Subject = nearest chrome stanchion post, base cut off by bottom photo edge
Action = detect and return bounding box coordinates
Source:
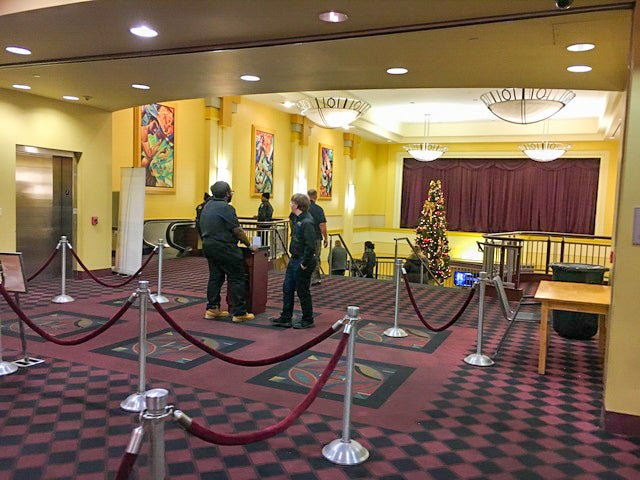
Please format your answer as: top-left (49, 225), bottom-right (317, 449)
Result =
top-left (142, 388), bottom-right (173, 480)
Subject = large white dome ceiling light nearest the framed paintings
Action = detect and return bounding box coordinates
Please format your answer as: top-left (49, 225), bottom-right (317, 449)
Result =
top-left (296, 97), bottom-right (371, 128)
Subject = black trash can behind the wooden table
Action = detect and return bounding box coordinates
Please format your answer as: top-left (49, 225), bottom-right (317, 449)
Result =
top-left (549, 263), bottom-right (609, 340)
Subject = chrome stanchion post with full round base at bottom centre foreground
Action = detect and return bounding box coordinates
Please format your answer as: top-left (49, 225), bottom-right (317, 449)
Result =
top-left (322, 306), bottom-right (369, 465)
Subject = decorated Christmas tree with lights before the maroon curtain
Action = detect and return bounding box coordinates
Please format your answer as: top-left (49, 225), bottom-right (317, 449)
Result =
top-left (416, 180), bottom-right (451, 282)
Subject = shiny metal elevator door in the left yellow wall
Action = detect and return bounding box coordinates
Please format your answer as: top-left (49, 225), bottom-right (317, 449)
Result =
top-left (16, 153), bottom-right (74, 278)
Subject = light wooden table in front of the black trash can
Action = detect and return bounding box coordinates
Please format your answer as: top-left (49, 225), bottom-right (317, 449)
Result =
top-left (534, 280), bottom-right (611, 375)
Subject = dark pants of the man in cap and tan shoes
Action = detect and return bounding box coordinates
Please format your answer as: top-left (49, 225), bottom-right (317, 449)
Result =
top-left (203, 238), bottom-right (247, 316)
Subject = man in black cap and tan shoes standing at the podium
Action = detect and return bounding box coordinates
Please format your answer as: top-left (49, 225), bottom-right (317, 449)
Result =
top-left (200, 181), bottom-right (256, 322)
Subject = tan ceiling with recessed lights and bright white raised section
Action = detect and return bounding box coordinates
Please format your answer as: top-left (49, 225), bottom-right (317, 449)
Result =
top-left (0, 0), bottom-right (635, 142)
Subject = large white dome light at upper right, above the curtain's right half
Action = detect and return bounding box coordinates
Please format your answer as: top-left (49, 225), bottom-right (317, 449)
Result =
top-left (480, 88), bottom-right (576, 124)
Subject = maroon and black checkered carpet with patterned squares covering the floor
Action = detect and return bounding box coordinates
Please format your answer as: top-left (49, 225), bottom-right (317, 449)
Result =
top-left (0, 258), bottom-right (640, 480)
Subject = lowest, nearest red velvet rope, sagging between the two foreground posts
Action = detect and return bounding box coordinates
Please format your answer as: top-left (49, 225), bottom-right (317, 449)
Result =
top-left (180, 333), bottom-right (351, 445)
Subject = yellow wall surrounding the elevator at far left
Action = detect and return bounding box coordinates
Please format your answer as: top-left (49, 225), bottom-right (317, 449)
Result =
top-left (0, 90), bottom-right (112, 269)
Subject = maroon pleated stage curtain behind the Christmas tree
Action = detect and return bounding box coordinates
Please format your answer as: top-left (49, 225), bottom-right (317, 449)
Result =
top-left (400, 158), bottom-right (600, 234)
